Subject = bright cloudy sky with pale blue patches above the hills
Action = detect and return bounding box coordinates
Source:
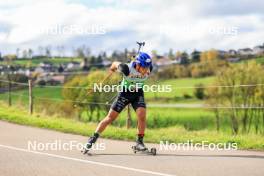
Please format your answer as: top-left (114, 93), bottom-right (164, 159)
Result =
top-left (0, 0), bottom-right (264, 54)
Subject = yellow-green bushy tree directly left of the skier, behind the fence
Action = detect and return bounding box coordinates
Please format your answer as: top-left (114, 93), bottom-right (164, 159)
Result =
top-left (63, 71), bottom-right (119, 121)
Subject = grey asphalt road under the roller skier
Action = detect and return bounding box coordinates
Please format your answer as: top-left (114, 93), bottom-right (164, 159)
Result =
top-left (0, 121), bottom-right (264, 176)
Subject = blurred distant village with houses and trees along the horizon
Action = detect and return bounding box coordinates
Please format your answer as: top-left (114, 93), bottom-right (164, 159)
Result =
top-left (0, 43), bottom-right (264, 85)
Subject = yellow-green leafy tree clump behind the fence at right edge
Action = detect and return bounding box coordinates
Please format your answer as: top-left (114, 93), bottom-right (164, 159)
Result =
top-left (206, 62), bottom-right (264, 134)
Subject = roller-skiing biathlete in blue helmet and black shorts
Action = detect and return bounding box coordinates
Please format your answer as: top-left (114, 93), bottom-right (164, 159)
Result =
top-left (84, 52), bottom-right (152, 153)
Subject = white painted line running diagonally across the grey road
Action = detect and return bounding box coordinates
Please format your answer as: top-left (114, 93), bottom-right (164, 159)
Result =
top-left (0, 144), bottom-right (176, 176)
